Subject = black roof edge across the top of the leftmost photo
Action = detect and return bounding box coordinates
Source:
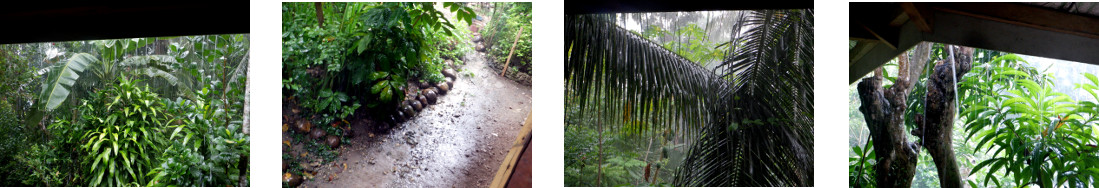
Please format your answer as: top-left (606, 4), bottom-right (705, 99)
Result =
top-left (0, 1), bottom-right (249, 44)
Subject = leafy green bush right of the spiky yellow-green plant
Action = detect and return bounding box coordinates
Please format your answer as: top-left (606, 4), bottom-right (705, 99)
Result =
top-left (143, 86), bottom-right (249, 187)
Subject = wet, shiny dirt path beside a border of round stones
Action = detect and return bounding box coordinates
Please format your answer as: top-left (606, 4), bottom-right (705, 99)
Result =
top-left (292, 13), bottom-right (531, 187)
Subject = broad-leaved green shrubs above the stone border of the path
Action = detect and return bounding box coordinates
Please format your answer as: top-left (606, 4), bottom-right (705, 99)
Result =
top-left (282, 2), bottom-right (476, 123)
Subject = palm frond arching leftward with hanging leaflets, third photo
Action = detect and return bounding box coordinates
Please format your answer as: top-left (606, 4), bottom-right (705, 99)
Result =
top-left (565, 15), bottom-right (725, 137)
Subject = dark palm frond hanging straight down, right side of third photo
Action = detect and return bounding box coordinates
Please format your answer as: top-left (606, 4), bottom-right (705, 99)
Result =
top-left (677, 10), bottom-right (813, 186)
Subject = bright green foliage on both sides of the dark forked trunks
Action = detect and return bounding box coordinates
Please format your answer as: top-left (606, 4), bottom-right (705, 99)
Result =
top-left (850, 44), bottom-right (1099, 187)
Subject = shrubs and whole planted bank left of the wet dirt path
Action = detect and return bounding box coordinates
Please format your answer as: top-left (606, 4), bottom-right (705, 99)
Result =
top-left (282, 2), bottom-right (477, 187)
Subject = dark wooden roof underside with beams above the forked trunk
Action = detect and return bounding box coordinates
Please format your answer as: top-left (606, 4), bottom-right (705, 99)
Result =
top-left (848, 2), bottom-right (1099, 82)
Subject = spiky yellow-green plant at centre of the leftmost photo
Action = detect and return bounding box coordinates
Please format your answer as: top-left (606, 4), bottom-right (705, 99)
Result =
top-left (80, 77), bottom-right (171, 186)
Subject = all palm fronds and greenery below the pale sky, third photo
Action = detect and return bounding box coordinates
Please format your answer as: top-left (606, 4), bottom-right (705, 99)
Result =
top-left (565, 10), bottom-right (813, 186)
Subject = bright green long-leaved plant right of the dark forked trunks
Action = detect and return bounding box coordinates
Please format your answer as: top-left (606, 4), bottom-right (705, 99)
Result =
top-left (958, 54), bottom-right (1099, 187)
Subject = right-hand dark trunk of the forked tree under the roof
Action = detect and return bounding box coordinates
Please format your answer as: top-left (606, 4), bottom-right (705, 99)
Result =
top-left (912, 46), bottom-right (974, 188)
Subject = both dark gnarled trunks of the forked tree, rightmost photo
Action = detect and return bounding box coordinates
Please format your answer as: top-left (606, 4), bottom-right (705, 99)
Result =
top-left (858, 43), bottom-right (974, 188)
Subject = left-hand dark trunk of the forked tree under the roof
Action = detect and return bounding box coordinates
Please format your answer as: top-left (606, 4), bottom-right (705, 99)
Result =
top-left (857, 43), bottom-right (931, 187)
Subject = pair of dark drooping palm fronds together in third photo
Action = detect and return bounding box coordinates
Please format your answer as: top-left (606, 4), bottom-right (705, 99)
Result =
top-left (565, 10), bottom-right (813, 186)
